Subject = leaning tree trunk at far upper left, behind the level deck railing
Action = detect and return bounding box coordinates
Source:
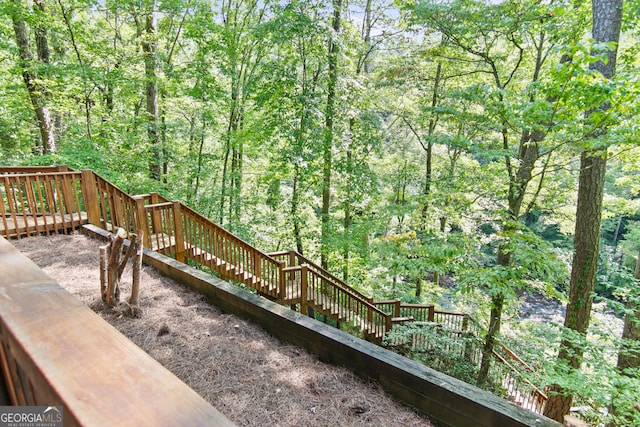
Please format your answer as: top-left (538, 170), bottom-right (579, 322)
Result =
top-left (11, 0), bottom-right (56, 154)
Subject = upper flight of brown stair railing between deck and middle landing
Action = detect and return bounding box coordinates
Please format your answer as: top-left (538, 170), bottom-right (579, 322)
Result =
top-left (83, 172), bottom-right (286, 299)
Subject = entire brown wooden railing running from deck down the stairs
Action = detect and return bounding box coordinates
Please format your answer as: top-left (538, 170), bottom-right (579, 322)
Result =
top-left (0, 166), bottom-right (546, 418)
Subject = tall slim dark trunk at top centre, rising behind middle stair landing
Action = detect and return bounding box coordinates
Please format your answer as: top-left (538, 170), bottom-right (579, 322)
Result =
top-left (320, 0), bottom-right (342, 269)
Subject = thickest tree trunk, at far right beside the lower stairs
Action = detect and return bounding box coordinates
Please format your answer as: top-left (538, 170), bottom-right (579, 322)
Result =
top-left (544, 0), bottom-right (623, 421)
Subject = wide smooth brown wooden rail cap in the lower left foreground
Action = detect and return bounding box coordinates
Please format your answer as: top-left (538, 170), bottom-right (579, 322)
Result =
top-left (0, 238), bottom-right (233, 426)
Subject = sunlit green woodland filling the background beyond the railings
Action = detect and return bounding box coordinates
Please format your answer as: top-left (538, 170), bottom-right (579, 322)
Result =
top-left (0, 0), bottom-right (640, 425)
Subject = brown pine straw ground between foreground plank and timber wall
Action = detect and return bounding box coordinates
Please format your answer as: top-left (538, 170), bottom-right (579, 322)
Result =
top-left (11, 234), bottom-right (431, 426)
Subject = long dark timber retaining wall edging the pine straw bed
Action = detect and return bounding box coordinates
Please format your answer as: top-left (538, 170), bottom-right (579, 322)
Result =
top-left (84, 225), bottom-right (560, 427)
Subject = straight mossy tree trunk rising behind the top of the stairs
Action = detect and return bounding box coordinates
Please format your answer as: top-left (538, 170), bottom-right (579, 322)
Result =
top-left (142, 5), bottom-right (162, 181)
